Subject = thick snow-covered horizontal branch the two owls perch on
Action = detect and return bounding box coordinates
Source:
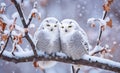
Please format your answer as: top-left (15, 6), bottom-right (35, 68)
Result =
top-left (1, 50), bottom-right (120, 72)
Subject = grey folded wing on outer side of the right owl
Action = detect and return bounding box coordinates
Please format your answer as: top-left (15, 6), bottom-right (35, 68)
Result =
top-left (68, 31), bottom-right (87, 59)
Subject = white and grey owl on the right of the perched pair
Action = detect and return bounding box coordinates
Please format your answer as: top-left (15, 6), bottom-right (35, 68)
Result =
top-left (59, 19), bottom-right (89, 73)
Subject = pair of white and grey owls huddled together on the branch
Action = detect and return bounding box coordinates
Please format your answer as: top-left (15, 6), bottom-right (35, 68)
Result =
top-left (34, 17), bottom-right (89, 73)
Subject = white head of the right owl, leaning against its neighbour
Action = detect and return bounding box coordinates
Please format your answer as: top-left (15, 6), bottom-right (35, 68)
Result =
top-left (59, 19), bottom-right (79, 33)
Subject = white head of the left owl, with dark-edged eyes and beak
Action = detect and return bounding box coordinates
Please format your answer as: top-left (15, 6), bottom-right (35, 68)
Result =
top-left (39, 17), bottom-right (60, 33)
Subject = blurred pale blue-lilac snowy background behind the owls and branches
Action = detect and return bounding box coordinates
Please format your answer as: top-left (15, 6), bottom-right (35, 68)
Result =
top-left (0, 0), bottom-right (120, 73)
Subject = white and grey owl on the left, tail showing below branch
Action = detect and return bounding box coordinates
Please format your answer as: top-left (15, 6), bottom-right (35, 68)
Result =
top-left (34, 17), bottom-right (60, 69)
